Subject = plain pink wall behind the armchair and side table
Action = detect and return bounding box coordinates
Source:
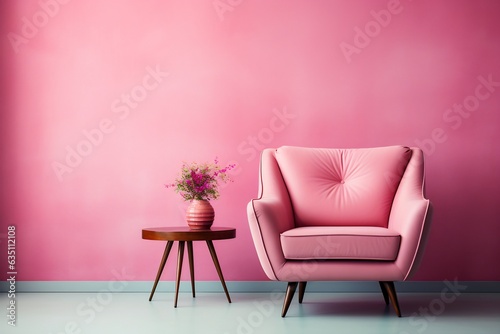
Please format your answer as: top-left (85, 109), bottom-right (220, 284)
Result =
top-left (0, 0), bottom-right (500, 281)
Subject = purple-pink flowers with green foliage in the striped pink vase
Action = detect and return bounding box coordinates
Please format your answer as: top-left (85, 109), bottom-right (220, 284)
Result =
top-left (165, 158), bottom-right (236, 201)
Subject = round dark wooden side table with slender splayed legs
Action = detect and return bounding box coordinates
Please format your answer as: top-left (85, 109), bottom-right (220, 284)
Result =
top-left (142, 226), bottom-right (236, 307)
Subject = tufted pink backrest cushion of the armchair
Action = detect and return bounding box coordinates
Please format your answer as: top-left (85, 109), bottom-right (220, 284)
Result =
top-left (275, 146), bottom-right (412, 227)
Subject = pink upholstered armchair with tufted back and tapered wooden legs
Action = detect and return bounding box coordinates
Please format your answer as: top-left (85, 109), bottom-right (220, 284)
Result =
top-left (247, 146), bottom-right (432, 317)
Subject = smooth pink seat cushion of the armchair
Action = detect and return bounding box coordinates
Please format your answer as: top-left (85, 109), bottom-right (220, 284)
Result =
top-left (280, 226), bottom-right (401, 261)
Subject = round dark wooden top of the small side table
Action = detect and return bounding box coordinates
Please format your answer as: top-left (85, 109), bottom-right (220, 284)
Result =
top-left (142, 226), bottom-right (236, 241)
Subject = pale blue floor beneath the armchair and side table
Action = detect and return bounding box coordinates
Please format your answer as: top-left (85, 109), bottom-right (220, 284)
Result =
top-left (0, 292), bottom-right (500, 334)
